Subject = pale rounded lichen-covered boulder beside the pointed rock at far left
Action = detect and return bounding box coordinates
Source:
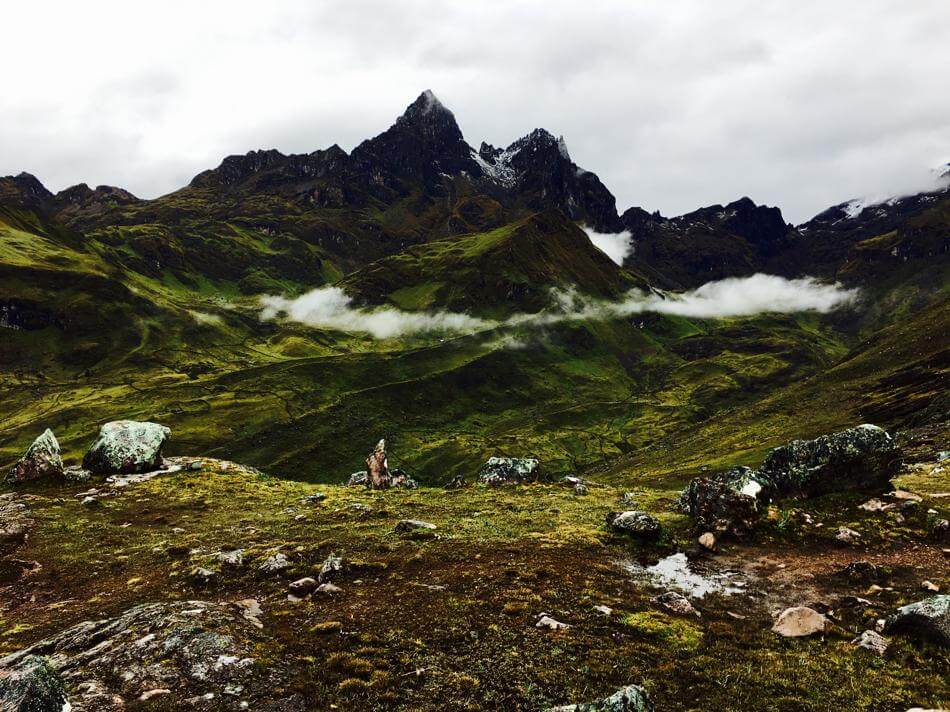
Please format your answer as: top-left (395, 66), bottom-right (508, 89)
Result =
top-left (82, 420), bottom-right (171, 475)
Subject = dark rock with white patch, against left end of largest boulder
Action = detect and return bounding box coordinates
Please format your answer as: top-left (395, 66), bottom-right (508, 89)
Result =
top-left (680, 467), bottom-right (766, 536)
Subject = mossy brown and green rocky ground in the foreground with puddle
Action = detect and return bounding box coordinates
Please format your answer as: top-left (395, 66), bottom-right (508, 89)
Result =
top-left (0, 431), bottom-right (950, 710)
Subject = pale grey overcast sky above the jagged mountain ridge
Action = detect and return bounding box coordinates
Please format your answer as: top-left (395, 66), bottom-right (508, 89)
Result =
top-left (0, 0), bottom-right (950, 222)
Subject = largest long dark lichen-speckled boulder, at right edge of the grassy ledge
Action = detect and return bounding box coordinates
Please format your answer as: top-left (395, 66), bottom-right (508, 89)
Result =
top-left (760, 424), bottom-right (901, 497)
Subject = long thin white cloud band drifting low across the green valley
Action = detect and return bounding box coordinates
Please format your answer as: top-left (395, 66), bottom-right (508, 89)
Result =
top-left (261, 274), bottom-right (859, 339)
